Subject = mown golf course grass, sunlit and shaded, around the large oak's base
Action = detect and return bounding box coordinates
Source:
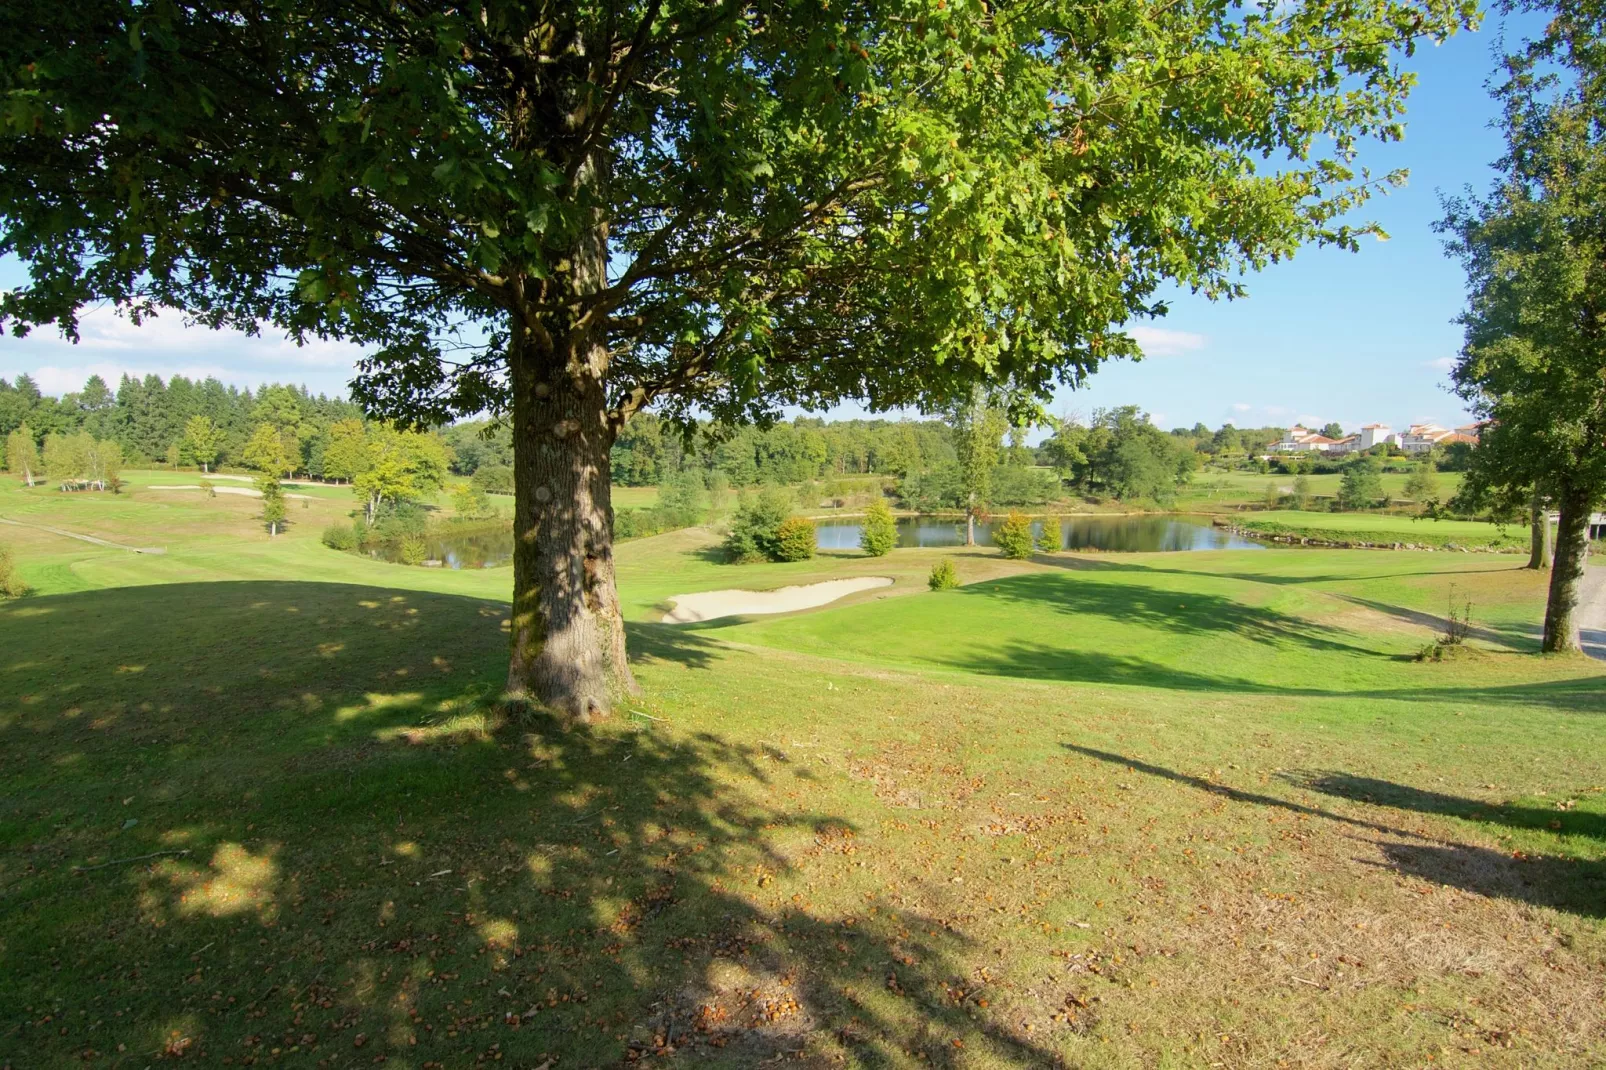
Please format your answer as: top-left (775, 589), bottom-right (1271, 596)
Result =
top-left (0, 482), bottom-right (1606, 1070)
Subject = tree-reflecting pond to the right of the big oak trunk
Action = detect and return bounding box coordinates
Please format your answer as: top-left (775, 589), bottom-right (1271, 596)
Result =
top-left (817, 514), bottom-right (1264, 553)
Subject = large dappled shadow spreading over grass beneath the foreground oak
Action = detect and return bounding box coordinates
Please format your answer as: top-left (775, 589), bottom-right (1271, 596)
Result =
top-left (0, 583), bottom-right (1058, 1067)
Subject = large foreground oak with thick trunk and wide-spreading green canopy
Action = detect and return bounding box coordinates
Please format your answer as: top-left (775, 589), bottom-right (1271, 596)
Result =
top-left (0, 0), bottom-right (1474, 717)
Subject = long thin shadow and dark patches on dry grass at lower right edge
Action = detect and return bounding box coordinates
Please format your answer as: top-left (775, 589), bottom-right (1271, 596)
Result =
top-left (1062, 744), bottom-right (1606, 917)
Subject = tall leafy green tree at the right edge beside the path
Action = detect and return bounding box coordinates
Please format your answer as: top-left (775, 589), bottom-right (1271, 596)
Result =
top-left (1442, 77), bottom-right (1606, 651)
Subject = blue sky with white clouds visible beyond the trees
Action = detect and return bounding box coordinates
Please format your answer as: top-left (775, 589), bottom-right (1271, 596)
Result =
top-left (0, 14), bottom-right (1554, 427)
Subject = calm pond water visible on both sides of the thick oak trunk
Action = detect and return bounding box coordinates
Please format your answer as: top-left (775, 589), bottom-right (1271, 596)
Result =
top-left (373, 514), bottom-right (1264, 569)
